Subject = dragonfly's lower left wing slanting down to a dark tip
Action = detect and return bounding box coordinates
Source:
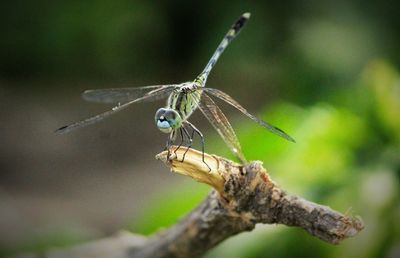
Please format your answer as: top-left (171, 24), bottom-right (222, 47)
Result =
top-left (56, 85), bottom-right (176, 133)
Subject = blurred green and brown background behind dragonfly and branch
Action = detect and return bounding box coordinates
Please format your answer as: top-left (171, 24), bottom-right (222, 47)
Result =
top-left (0, 0), bottom-right (400, 258)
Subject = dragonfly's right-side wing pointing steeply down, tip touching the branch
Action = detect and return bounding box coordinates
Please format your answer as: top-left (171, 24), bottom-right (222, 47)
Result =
top-left (199, 92), bottom-right (246, 163)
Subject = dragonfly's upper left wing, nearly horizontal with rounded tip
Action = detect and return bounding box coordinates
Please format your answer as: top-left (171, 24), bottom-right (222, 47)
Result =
top-left (82, 85), bottom-right (171, 104)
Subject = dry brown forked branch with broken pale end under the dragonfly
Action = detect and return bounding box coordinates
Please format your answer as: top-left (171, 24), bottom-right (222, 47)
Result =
top-left (23, 148), bottom-right (364, 258)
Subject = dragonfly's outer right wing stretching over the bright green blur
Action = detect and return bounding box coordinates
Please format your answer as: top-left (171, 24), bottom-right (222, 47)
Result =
top-left (203, 88), bottom-right (296, 142)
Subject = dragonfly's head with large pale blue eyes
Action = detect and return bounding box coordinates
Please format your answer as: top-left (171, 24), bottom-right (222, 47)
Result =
top-left (155, 108), bottom-right (182, 133)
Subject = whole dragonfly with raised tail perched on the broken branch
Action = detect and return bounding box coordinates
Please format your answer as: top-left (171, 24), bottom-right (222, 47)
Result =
top-left (56, 12), bottom-right (295, 169)
